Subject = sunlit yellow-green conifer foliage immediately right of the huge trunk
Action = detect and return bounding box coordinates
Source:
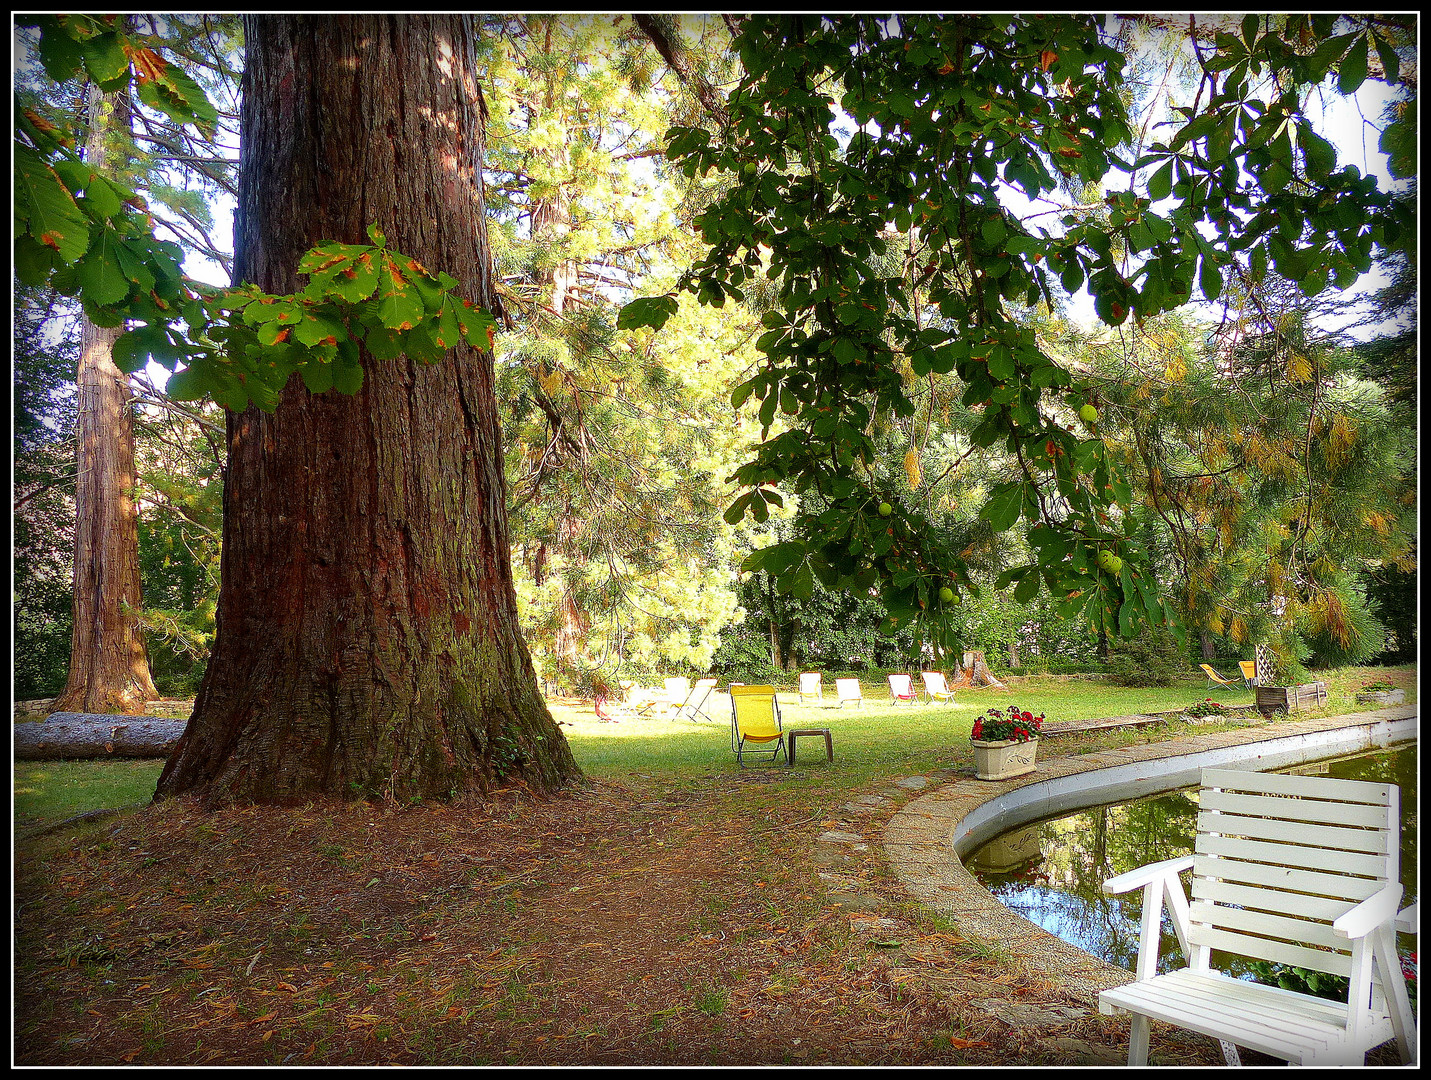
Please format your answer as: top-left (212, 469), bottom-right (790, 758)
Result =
top-left (488, 16), bottom-right (754, 687)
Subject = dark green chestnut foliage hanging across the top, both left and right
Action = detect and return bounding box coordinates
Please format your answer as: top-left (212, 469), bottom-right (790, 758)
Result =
top-left (14, 14), bottom-right (1414, 675)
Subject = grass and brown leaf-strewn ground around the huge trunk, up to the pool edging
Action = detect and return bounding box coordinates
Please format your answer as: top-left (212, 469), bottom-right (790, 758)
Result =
top-left (14, 668), bottom-right (1415, 1066)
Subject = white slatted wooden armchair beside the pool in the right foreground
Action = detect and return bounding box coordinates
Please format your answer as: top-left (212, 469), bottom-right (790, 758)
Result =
top-left (1098, 768), bottom-right (1417, 1066)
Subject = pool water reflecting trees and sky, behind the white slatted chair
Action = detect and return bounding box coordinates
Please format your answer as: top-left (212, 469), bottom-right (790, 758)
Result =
top-left (967, 745), bottom-right (1417, 976)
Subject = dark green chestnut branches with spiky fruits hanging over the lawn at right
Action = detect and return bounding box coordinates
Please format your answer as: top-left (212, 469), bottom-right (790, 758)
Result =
top-left (622, 14), bottom-right (1411, 644)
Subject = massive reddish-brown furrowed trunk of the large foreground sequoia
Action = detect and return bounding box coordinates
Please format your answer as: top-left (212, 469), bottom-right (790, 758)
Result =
top-left (156, 16), bottom-right (580, 805)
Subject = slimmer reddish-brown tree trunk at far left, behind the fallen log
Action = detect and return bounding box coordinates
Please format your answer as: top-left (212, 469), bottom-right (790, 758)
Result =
top-left (54, 86), bottom-right (159, 714)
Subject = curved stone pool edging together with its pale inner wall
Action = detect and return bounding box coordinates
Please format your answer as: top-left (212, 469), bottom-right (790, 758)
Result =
top-left (883, 705), bottom-right (1418, 1004)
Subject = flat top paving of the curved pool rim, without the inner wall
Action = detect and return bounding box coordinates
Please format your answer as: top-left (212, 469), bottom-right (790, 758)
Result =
top-left (881, 705), bottom-right (1417, 1007)
